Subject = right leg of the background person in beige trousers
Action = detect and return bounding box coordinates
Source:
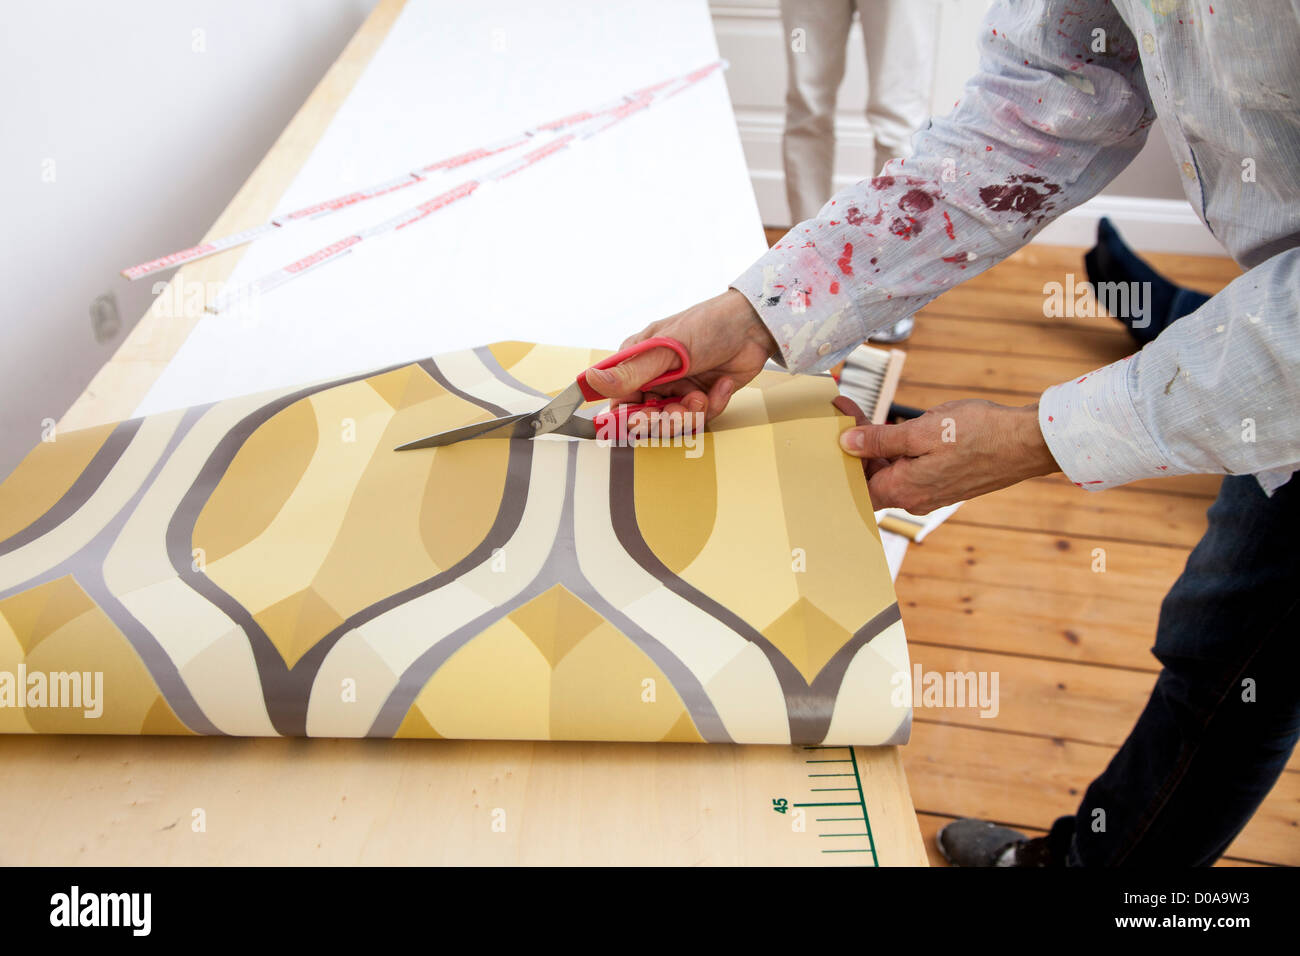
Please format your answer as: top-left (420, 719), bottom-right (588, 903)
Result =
top-left (857, 0), bottom-right (939, 345)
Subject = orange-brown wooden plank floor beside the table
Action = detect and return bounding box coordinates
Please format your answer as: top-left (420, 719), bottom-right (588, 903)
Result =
top-left (770, 230), bottom-right (1300, 865)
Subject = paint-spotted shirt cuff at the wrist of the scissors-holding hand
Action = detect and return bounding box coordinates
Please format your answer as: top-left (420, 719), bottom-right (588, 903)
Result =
top-left (731, 255), bottom-right (871, 372)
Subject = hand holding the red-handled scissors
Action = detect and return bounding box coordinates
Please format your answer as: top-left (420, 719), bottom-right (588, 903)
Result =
top-left (586, 289), bottom-right (776, 423)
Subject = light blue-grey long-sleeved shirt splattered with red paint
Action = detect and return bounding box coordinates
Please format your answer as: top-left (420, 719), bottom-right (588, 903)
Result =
top-left (733, 0), bottom-right (1300, 493)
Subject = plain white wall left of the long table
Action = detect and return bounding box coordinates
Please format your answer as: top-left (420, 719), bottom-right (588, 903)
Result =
top-left (0, 0), bottom-right (376, 476)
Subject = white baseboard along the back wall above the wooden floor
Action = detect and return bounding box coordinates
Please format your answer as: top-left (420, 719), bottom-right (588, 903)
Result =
top-left (749, 169), bottom-right (1226, 256)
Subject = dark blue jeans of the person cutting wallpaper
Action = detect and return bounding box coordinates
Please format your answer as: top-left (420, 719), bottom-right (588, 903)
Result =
top-left (1048, 476), bottom-right (1300, 866)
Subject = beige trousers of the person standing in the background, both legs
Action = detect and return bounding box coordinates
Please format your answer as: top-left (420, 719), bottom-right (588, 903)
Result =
top-left (781, 0), bottom-right (939, 222)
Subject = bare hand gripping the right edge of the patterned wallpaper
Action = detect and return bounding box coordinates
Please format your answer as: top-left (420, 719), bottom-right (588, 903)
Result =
top-left (840, 398), bottom-right (1061, 515)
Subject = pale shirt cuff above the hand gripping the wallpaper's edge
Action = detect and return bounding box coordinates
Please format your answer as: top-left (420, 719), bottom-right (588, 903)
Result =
top-left (1039, 359), bottom-right (1182, 492)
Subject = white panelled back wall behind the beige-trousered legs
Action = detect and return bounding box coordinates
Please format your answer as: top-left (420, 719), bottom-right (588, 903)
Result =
top-left (710, 0), bottom-right (1222, 255)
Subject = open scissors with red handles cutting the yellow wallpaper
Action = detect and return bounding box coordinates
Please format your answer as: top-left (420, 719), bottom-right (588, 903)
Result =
top-left (394, 336), bottom-right (690, 451)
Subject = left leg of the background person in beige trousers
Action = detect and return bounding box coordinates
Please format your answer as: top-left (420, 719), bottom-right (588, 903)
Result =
top-left (781, 0), bottom-right (853, 224)
